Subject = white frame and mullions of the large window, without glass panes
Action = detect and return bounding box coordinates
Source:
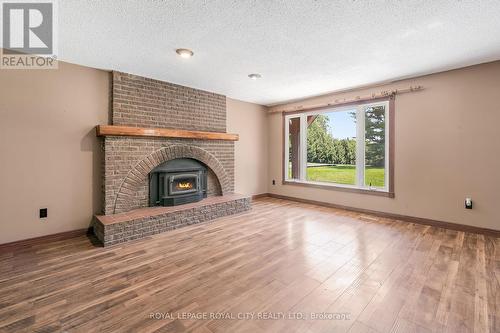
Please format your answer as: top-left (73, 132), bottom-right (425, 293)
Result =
top-left (283, 100), bottom-right (392, 192)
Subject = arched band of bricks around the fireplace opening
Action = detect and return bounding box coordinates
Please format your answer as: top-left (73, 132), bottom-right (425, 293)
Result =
top-left (113, 145), bottom-right (231, 214)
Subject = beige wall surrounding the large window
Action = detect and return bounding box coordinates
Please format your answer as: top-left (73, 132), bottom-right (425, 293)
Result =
top-left (269, 61), bottom-right (500, 229)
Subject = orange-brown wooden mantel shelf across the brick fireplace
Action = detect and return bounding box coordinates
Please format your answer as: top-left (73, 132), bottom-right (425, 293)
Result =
top-left (96, 125), bottom-right (239, 141)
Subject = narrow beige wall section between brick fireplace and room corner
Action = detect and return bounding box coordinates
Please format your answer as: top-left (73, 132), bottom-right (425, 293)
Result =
top-left (226, 98), bottom-right (269, 195)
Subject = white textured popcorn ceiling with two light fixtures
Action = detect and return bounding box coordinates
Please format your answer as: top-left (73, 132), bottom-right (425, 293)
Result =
top-left (59, 0), bottom-right (500, 104)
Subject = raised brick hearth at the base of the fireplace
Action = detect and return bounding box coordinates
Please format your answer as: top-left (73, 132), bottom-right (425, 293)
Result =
top-left (94, 194), bottom-right (251, 246)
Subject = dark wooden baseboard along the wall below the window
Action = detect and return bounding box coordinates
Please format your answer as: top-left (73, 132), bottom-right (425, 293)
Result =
top-left (259, 193), bottom-right (500, 238)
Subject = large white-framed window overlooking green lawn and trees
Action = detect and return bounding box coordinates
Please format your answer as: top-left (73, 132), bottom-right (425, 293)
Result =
top-left (284, 100), bottom-right (392, 193)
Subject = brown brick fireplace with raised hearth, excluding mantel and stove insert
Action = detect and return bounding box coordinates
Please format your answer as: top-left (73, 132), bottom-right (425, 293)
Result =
top-left (94, 72), bottom-right (250, 245)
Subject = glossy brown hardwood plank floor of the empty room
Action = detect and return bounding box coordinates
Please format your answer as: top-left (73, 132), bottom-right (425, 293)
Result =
top-left (0, 198), bottom-right (500, 333)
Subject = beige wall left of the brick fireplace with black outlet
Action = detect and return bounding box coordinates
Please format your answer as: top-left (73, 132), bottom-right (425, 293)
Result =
top-left (0, 63), bottom-right (110, 243)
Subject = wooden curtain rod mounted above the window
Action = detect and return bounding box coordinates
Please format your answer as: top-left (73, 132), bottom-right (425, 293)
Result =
top-left (268, 85), bottom-right (424, 113)
